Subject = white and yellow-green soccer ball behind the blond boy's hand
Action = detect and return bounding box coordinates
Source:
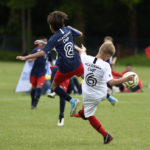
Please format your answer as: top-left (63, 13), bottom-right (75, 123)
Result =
top-left (123, 71), bottom-right (139, 89)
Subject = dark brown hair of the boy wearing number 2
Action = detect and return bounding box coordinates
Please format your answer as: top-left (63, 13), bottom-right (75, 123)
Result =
top-left (47, 11), bottom-right (68, 31)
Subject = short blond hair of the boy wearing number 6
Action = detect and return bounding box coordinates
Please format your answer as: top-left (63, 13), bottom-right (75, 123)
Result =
top-left (99, 41), bottom-right (116, 56)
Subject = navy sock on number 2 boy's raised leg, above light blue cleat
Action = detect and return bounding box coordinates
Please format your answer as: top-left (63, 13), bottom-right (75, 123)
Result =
top-left (55, 86), bottom-right (72, 101)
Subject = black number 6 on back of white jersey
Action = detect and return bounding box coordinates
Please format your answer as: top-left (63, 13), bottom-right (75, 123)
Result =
top-left (85, 73), bottom-right (97, 87)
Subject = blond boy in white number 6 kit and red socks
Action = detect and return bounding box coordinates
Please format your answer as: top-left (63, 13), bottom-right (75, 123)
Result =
top-left (75, 42), bottom-right (134, 144)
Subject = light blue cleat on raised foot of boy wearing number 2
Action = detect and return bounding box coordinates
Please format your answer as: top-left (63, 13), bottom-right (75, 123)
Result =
top-left (70, 98), bottom-right (80, 117)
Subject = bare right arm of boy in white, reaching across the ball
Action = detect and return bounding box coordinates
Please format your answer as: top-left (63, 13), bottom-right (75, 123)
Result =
top-left (108, 75), bottom-right (134, 85)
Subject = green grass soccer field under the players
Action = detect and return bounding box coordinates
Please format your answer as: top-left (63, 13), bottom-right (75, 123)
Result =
top-left (0, 62), bottom-right (150, 150)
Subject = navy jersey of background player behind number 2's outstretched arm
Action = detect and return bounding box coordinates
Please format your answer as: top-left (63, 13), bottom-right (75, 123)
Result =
top-left (30, 48), bottom-right (46, 77)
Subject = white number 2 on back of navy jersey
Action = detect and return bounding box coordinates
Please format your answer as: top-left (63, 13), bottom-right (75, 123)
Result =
top-left (64, 42), bottom-right (74, 58)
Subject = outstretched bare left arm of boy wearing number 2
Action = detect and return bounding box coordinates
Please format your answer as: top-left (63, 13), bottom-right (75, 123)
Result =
top-left (16, 50), bottom-right (46, 61)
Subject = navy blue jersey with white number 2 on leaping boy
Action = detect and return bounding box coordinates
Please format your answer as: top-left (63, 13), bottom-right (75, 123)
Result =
top-left (43, 26), bottom-right (81, 73)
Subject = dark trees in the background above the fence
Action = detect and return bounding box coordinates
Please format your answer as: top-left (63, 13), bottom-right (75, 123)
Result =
top-left (0, 0), bottom-right (150, 53)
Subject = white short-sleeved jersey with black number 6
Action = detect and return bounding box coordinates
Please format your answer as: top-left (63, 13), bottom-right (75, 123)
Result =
top-left (81, 54), bottom-right (113, 99)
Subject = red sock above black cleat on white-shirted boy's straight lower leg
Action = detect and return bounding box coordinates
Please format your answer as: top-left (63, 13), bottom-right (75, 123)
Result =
top-left (88, 116), bottom-right (107, 137)
